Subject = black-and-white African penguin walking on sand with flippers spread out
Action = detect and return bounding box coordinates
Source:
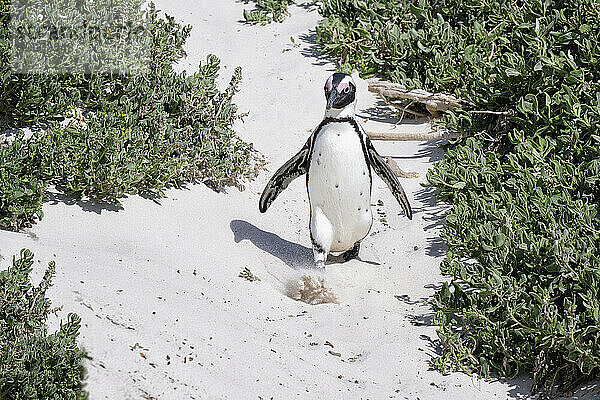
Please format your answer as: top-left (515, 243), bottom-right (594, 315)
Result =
top-left (259, 72), bottom-right (412, 268)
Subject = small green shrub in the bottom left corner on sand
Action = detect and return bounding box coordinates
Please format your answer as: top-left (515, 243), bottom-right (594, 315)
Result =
top-left (0, 250), bottom-right (88, 400)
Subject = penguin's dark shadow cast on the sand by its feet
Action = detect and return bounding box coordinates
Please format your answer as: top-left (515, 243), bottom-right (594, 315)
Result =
top-left (229, 219), bottom-right (380, 269)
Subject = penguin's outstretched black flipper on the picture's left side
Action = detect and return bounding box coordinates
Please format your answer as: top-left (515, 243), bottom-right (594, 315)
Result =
top-left (258, 137), bottom-right (312, 213)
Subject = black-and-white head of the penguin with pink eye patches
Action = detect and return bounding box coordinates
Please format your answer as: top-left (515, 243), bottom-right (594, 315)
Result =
top-left (325, 72), bottom-right (356, 118)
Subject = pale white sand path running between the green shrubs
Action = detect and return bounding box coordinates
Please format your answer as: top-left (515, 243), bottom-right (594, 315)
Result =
top-left (0, 0), bottom-right (580, 399)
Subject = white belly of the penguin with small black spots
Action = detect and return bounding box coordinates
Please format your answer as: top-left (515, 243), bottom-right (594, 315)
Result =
top-left (308, 123), bottom-right (373, 252)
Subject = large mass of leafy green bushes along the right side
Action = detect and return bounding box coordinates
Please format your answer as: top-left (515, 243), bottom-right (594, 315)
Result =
top-left (317, 0), bottom-right (600, 396)
